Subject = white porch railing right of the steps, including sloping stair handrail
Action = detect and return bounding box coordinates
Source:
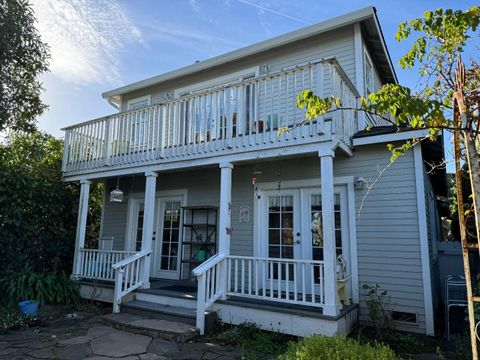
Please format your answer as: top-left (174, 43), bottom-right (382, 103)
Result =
top-left (193, 254), bottom-right (325, 334)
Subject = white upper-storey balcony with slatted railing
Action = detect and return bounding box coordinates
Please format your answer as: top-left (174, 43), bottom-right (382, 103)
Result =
top-left (63, 59), bottom-right (359, 177)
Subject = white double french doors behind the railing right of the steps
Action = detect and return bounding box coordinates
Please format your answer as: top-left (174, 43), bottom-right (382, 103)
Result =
top-left (259, 186), bottom-right (350, 296)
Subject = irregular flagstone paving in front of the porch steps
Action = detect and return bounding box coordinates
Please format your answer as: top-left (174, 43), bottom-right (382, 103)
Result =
top-left (0, 314), bottom-right (240, 360)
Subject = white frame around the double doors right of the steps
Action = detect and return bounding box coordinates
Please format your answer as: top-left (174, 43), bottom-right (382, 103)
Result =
top-left (253, 176), bottom-right (359, 304)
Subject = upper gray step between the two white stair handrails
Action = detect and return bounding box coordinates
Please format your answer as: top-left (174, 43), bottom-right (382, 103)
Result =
top-left (121, 300), bottom-right (217, 331)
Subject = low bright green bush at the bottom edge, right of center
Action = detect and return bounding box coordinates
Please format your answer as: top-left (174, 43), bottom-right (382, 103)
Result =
top-left (279, 335), bottom-right (399, 360)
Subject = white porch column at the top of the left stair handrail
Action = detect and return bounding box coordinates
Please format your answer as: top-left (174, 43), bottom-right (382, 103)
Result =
top-left (142, 172), bottom-right (158, 288)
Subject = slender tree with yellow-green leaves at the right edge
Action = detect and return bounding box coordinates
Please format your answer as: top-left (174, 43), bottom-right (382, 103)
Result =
top-left (297, 6), bottom-right (480, 358)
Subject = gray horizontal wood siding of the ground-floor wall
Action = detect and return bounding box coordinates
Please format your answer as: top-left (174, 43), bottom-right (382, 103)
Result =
top-left (99, 145), bottom-right (425, 332)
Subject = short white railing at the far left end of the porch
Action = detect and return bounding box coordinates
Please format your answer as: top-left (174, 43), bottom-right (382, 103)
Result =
top-left (75, 249), bottom-right (135, 281)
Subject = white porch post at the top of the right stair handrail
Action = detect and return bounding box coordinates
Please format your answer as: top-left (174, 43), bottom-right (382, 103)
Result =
top-left (218, 163), bottom-right (233, 299)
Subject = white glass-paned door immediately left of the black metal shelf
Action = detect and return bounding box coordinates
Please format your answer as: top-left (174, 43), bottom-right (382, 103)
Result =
top-left (152, 196), bottom-right (183, 279)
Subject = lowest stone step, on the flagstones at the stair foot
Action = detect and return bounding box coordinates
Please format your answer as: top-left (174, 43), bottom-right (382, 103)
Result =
top-left (103, 313), bottom-right (198, 342)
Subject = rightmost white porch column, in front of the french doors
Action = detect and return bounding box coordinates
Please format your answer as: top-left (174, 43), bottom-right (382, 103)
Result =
top-left (318, 150), bottom-right (339, 316)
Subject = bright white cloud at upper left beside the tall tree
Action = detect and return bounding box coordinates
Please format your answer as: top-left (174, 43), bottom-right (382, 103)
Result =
top-left (33, 0), bottom-right (143, 84)
